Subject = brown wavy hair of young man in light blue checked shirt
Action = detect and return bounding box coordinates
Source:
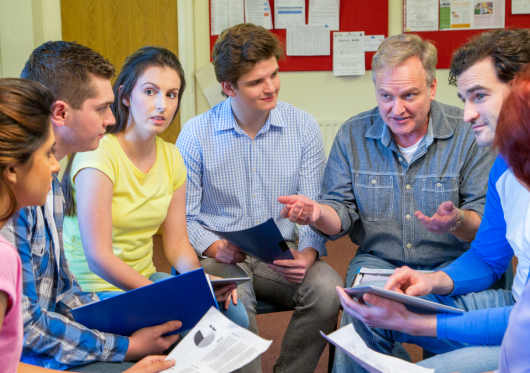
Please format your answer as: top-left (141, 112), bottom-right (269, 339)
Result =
top-left (212, 23), bottom-right (284, 97)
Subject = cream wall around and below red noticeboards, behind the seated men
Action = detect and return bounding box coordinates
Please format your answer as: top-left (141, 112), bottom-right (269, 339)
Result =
top-left (194, 0), bottom-right (463, 122)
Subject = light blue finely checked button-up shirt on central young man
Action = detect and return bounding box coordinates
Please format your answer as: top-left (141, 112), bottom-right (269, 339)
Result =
top-left (177, 98), bottom-right (327, 256)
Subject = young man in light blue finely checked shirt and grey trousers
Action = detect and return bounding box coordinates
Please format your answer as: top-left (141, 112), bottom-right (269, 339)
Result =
top-left (177, 24), bottom-right (342, 373)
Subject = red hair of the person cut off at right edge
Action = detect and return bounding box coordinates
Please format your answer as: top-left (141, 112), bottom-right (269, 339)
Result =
top-left (494, 64), bottom-right (530, 186)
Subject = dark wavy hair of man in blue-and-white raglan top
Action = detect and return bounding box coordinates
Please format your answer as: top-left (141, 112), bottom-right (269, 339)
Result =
top-left (449, 29), bottom-right (530, 85)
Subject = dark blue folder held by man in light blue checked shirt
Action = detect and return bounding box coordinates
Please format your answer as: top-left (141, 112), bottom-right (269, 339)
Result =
top-left (204, 219), bottom-right (294, 264)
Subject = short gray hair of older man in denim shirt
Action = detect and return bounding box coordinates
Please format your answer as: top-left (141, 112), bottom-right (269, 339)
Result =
top-left (372, 34), bottom-right (438, 86)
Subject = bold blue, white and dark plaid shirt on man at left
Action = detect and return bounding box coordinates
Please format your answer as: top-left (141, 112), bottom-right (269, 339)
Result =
top-left (0, 178), bottom-right (129, 370)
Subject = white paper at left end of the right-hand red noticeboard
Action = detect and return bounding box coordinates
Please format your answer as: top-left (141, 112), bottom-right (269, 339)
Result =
top-left (404, 0), bottom-right (439, 32)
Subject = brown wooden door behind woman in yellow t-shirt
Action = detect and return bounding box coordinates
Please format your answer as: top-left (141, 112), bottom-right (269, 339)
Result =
top-left (61, 0), bottom-right (180, 144)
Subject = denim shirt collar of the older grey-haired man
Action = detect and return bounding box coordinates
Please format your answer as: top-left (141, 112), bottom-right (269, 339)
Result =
top-left (364, 101), bottom-right (454, 148)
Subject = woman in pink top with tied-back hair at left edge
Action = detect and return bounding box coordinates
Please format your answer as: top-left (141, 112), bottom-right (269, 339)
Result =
top-left (0, 79), bottom-right (174, 373)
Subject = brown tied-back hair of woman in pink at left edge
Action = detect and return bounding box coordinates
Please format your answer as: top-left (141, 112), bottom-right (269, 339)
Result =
top-left (0, 78), bottom-right (55, 221)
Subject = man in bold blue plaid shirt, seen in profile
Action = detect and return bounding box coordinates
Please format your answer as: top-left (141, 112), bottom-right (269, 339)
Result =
top-left (0, 41), bottom-right (181, 372)
